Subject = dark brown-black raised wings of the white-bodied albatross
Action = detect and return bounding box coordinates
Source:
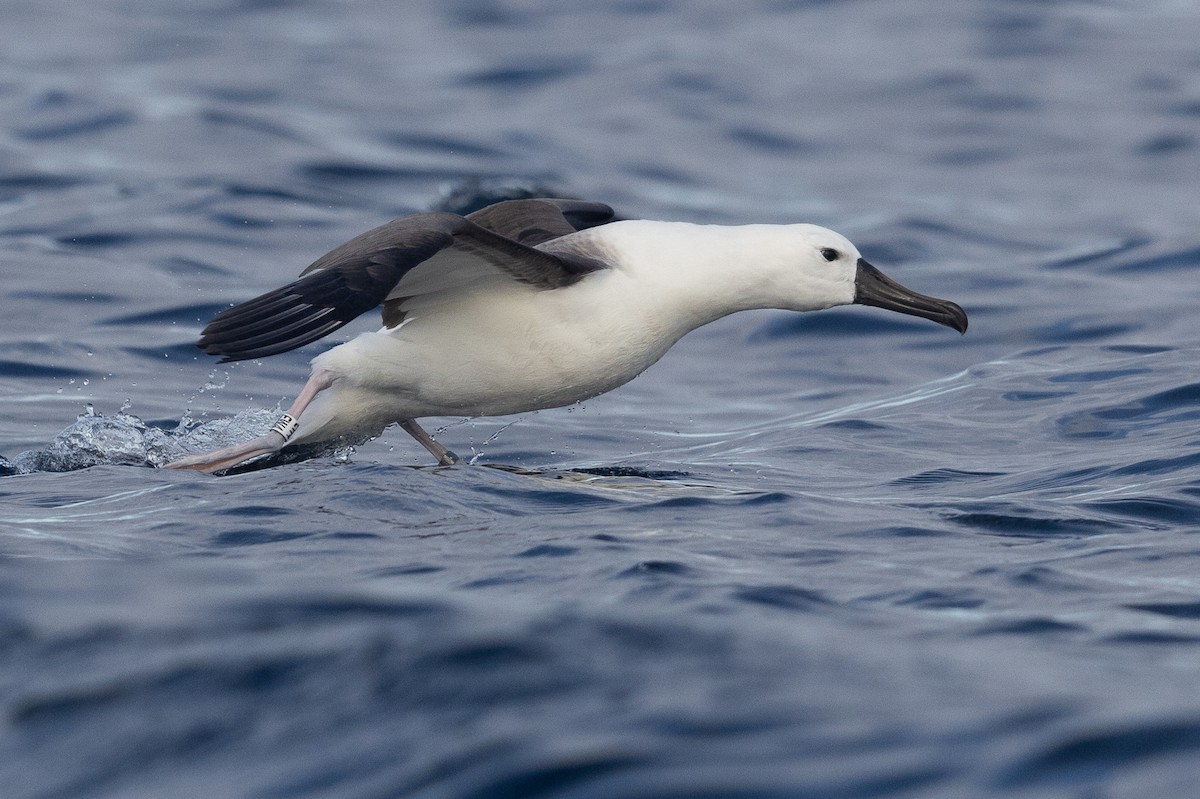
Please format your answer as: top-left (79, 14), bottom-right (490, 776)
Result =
top-left (197, 200), bottom-right (612, 362)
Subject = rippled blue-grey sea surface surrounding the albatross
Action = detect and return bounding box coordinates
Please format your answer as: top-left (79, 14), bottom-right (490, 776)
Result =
top-left (0, 0), bottom-right (1200, 799)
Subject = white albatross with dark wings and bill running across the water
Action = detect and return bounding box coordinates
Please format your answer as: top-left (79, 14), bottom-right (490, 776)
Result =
top-left (168, 199), bottom-right (967, 471)
